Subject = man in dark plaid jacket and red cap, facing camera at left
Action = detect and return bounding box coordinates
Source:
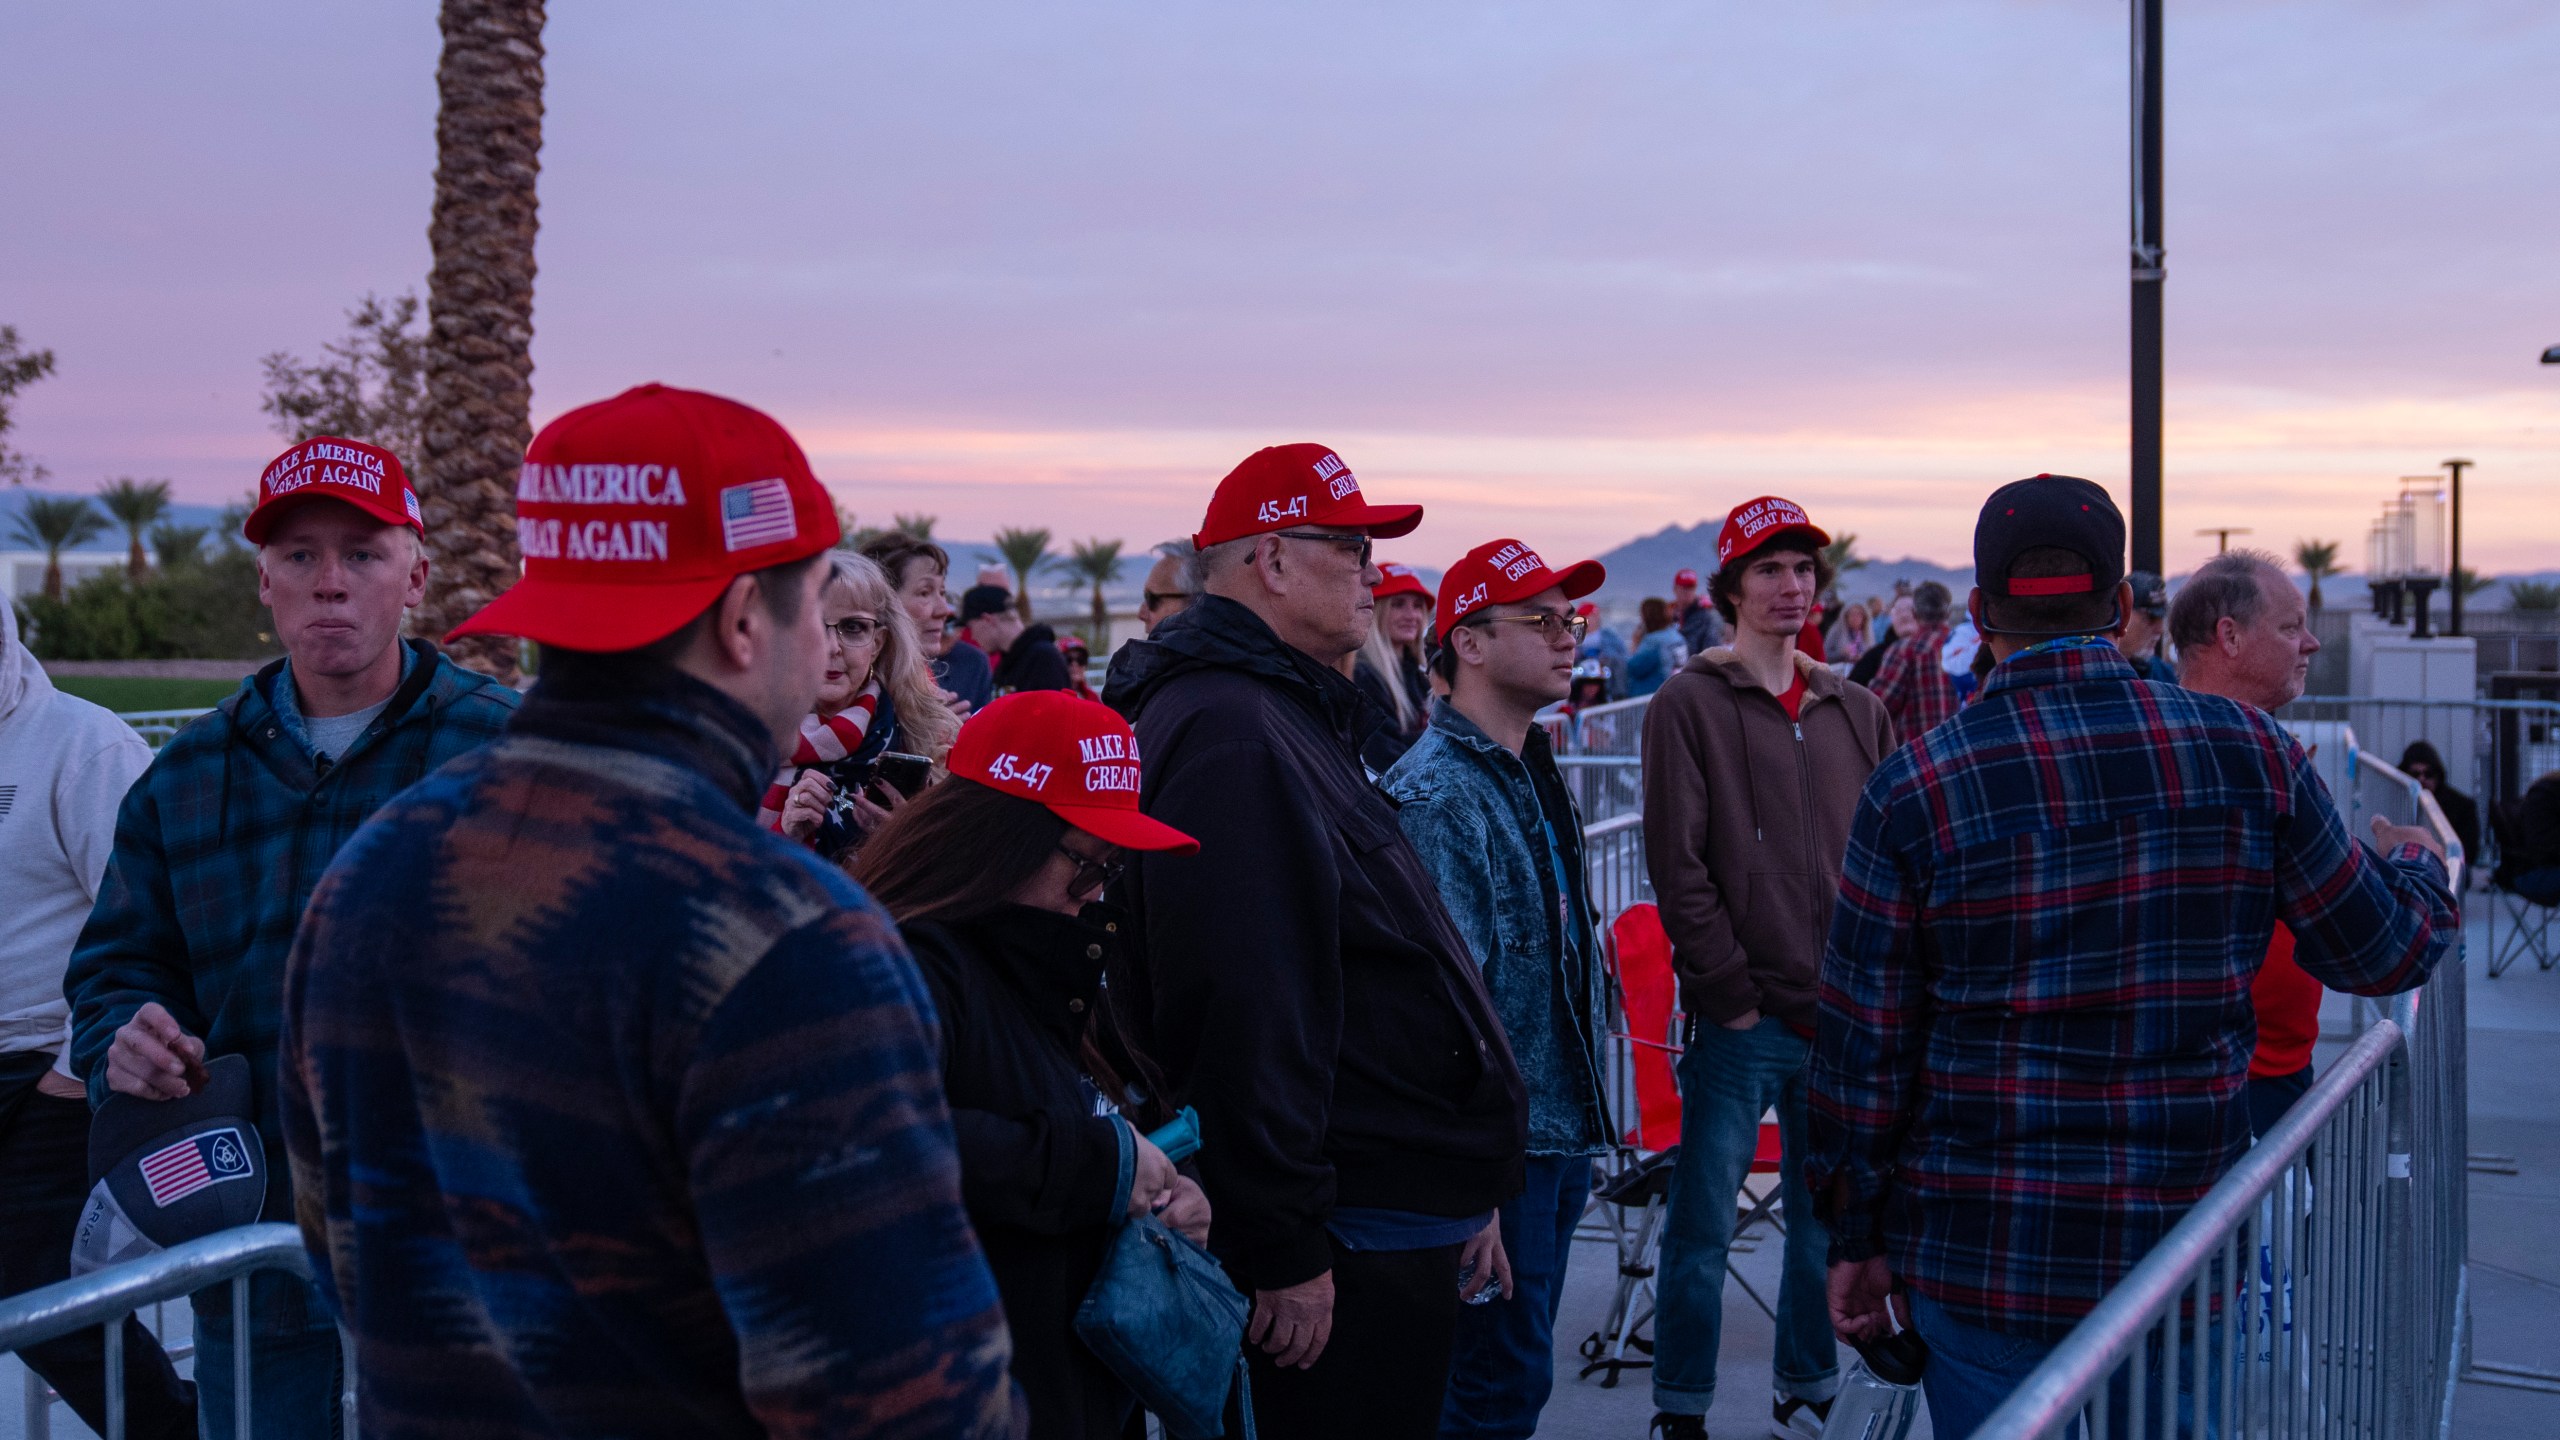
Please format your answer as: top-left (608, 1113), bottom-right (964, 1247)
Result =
top-left (64, 436), bottom-right (517, 1437)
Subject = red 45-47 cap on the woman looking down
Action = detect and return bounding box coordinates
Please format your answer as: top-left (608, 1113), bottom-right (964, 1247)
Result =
top-left (947, 689), bottom-right (1201, 856)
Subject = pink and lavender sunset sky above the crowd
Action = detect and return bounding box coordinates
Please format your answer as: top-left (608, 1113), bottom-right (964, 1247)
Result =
top-left (0, 0), bottom-right (2560, 571)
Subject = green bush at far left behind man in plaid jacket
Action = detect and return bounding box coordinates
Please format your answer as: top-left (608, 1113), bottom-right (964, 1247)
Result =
top-left (18, 546), bottom-right (282, 661)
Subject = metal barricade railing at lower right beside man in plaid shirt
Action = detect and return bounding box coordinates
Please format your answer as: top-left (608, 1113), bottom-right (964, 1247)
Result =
top-left (1976, 751), bottom-right (2470, 1440)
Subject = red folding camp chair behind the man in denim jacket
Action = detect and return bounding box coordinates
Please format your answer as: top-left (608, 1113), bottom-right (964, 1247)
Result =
top-left (1582, 904), bottom-right (1787, 1389)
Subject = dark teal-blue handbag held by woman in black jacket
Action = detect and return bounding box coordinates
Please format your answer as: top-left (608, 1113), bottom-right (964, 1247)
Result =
top-left (1075, 1215), bottom-right (1254, 1440)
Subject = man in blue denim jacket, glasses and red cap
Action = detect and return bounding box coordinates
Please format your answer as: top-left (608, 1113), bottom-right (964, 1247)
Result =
top-left (1385, 541), bottom-right (1610, 1440)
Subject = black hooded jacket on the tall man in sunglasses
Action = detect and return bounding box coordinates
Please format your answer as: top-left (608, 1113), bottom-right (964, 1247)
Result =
top-left (1103, 594), bottom-right (1528, 1289)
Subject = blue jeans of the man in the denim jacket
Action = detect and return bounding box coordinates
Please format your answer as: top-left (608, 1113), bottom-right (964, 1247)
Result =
top-left (1441, 1156), bottom-right (1592, 1440)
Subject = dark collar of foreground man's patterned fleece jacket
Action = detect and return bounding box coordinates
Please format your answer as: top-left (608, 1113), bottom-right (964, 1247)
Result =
top-left (507, 659), bottom-right (781, 812)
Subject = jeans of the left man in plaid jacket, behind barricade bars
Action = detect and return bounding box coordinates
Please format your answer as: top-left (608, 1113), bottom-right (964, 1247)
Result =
top-left (189, 1271), bottom-right (340, 1440)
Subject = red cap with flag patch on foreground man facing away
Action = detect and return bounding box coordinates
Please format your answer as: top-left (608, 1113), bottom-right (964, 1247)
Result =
top-left (448, 384), bottom-right (840, 651)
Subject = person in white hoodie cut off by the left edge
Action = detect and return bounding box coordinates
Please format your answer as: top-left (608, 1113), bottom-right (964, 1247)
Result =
top-left (0, 602), bottom-right (195, 1440)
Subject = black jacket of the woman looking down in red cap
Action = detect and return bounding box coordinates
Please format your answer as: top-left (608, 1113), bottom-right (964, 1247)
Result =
top-left (904, 904), bottom-right (1134, 1440)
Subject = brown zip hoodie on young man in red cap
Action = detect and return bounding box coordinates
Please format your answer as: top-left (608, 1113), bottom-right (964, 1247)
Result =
top-left (1644, 646), bottom-right (1894, 1030)
